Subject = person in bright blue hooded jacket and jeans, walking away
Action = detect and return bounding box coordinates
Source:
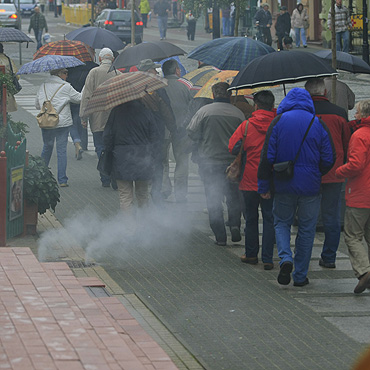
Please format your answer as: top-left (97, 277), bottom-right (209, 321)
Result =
top-left (258, 88), bottom-right (336, 286)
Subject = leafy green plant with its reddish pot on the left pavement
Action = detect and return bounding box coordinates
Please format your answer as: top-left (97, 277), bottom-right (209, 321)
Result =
top-left (23, 155), bottom-right (60, 234)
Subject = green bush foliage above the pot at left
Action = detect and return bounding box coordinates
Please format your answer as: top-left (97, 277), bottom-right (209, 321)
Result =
top-left (24, 155), bottom-right (60, 214)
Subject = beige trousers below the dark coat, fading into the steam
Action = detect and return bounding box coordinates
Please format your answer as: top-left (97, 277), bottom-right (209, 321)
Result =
top-left (117, 180), bottom-right (149, 212)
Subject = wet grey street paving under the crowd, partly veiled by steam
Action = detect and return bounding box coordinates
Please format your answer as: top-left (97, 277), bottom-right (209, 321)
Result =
top-left (5, 10), bottom-right (370, 370)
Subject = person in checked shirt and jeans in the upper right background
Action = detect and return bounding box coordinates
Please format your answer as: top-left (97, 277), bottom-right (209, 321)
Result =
top-left (327, 0), bottom-right (352, 53)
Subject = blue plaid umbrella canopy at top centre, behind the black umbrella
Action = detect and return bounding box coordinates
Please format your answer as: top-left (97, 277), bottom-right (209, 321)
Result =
top-left (188, 37), bottom-right (275, 71)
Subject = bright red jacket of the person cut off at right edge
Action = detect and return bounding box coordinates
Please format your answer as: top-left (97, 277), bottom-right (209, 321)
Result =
top-left (335, 117), bottom-right (370, 208)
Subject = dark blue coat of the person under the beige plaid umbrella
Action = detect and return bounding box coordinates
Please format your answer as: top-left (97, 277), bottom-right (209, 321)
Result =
top-left (103, 100), bottom-right (159, 181)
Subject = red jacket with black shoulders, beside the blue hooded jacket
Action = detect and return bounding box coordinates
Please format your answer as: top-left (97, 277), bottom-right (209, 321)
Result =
top-left (312, 96), bottom-right (351, 184)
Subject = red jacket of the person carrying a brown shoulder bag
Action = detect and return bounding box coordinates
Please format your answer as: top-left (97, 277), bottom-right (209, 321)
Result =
top-left (229, 109), bottom-right (276, 191)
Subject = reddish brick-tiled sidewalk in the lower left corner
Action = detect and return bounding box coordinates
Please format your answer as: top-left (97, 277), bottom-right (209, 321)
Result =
top-left (0, 248), bottom-right (176, 370)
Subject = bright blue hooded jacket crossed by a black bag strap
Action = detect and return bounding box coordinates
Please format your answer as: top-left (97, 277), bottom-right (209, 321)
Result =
top-left (258, 88), bottom-right (336, 196)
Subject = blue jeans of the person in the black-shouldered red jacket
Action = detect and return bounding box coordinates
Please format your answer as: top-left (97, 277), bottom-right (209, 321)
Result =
top-left (321, 182), bottom-right (342, 263)
